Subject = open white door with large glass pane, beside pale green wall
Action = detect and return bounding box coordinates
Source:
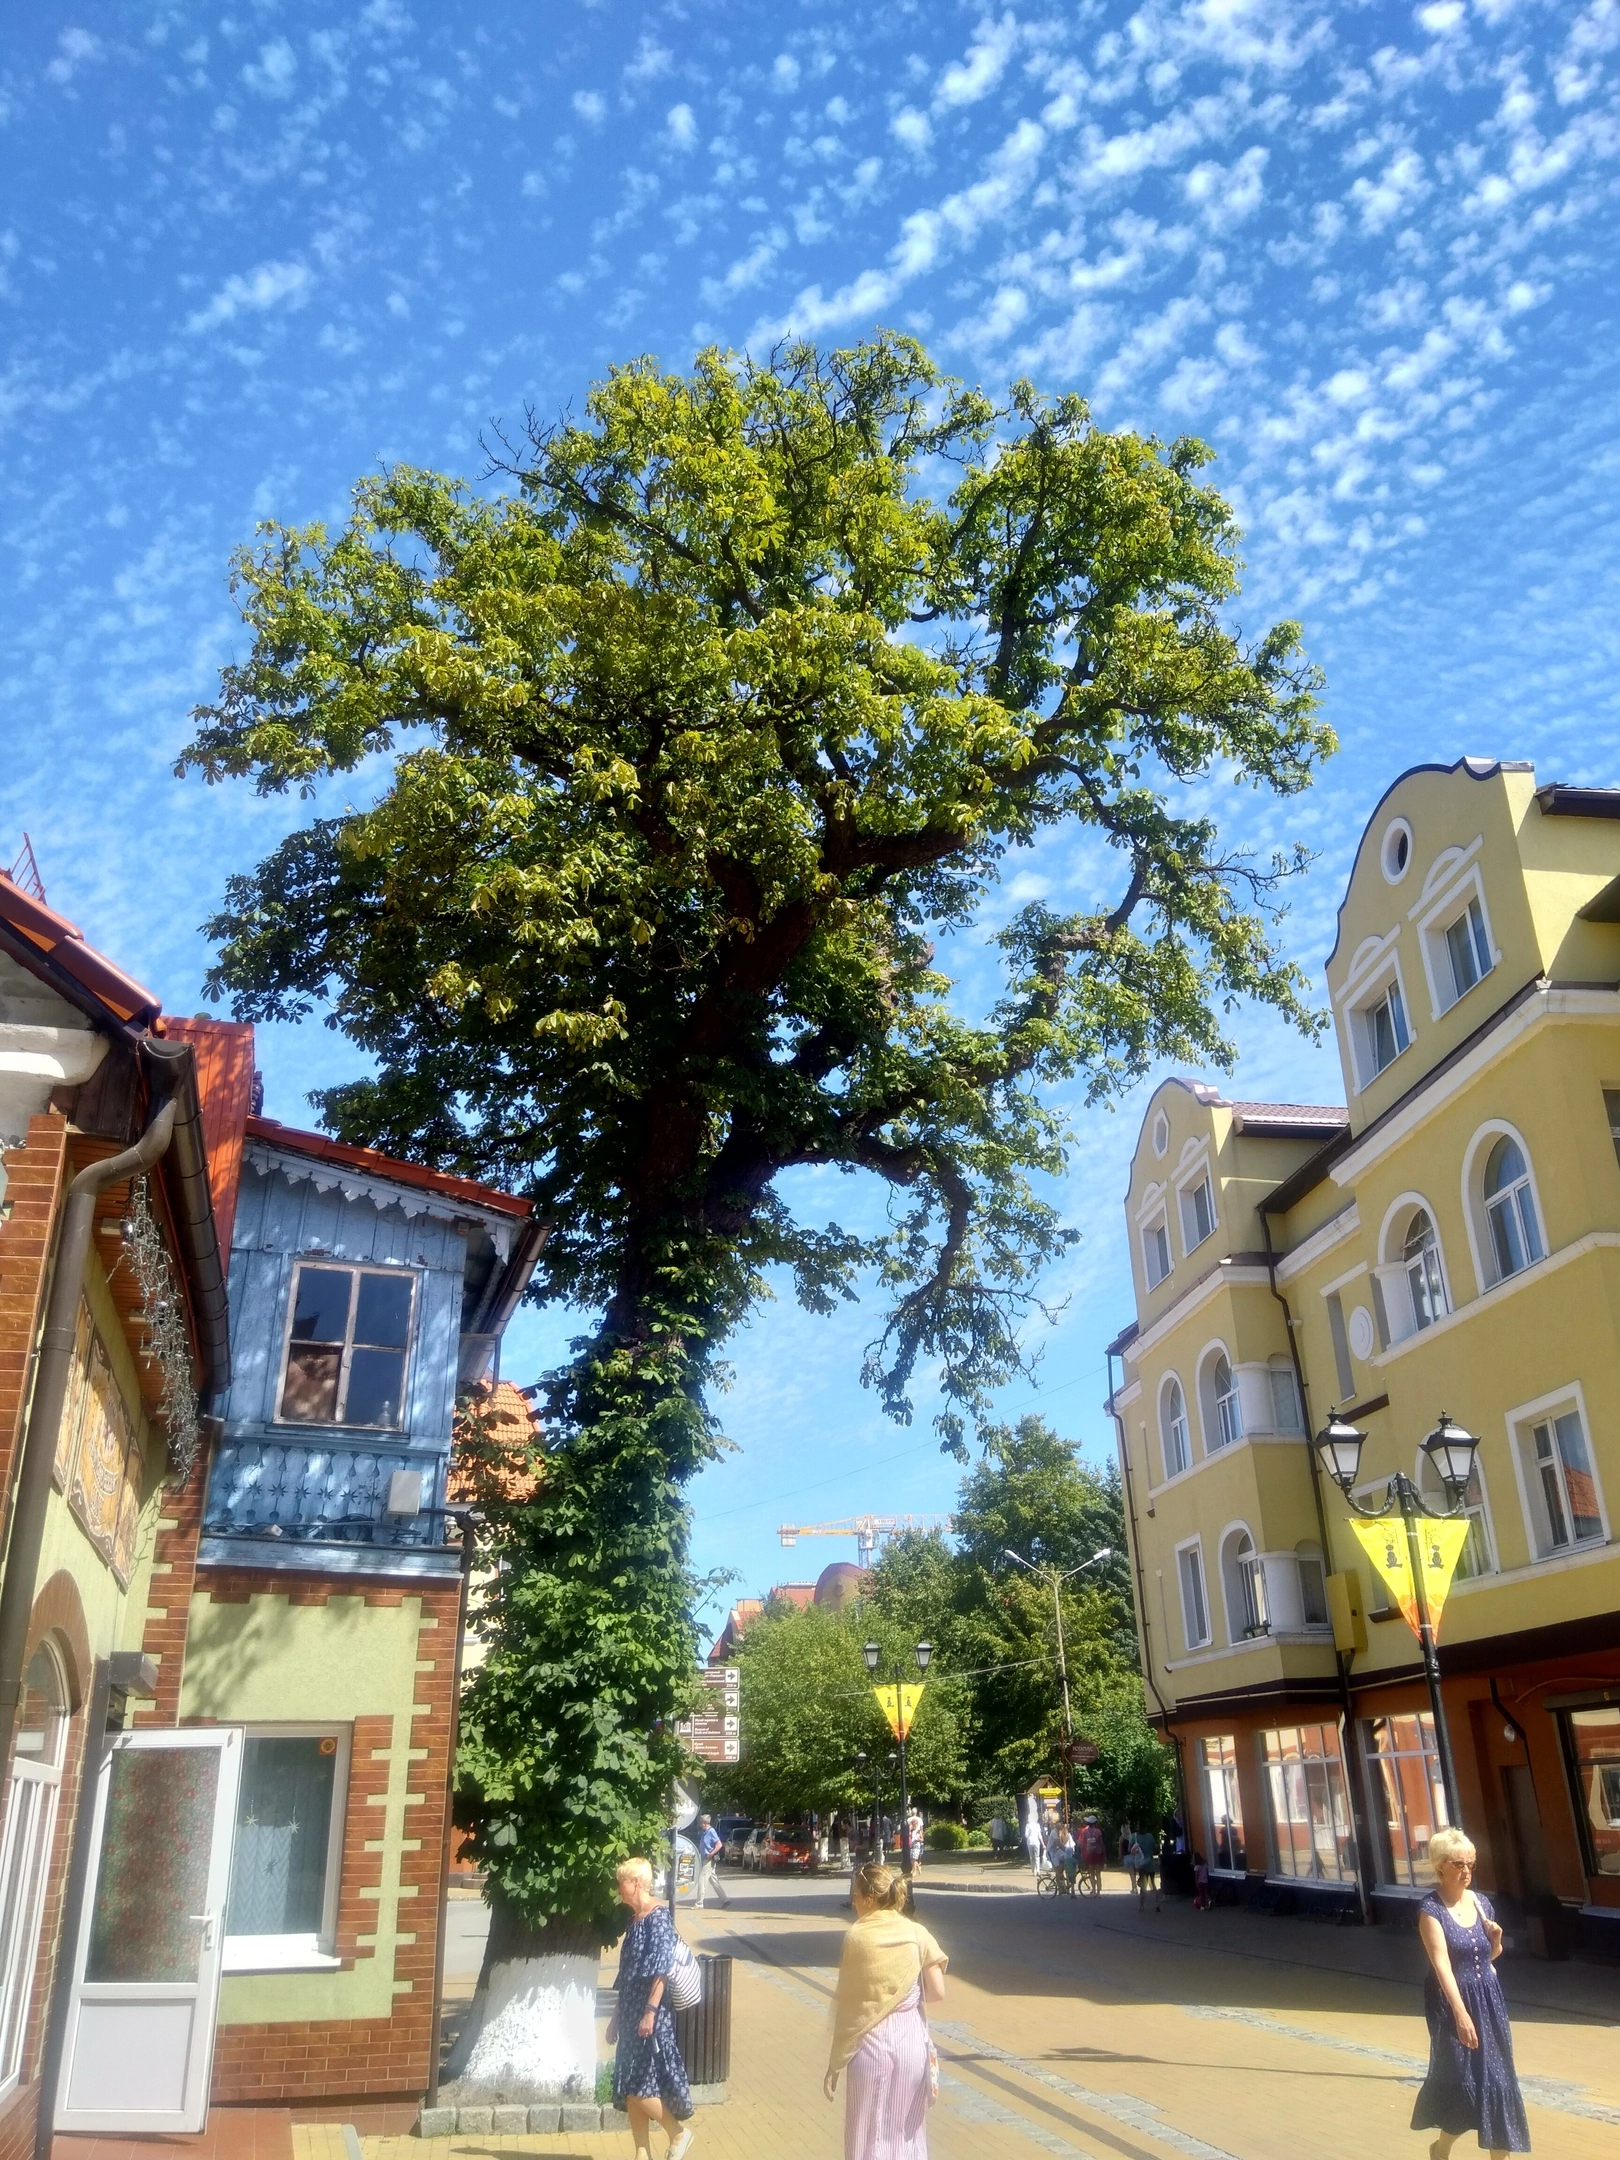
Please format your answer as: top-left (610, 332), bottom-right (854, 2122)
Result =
top-left (56, 1726), bottom-right (242, 2132)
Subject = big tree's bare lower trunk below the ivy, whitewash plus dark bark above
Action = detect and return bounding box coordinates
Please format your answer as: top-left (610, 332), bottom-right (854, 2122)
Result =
top-left (441, 1892), bottom-right (600, 2106)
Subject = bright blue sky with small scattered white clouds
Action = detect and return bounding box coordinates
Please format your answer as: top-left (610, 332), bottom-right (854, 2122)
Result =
top-left (0, 0), bottom-right (1620, 1632)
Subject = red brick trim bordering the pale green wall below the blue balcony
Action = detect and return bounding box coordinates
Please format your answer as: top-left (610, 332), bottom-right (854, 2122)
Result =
top-left (206, 1568), bottom-right (460, 2099)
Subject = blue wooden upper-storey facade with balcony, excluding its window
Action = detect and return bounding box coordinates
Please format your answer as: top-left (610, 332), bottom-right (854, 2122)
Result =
top-left (197, 1128), bottom-right (538, 1575)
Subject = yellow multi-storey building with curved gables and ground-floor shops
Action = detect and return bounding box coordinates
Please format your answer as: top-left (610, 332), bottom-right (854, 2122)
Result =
top-left (1110, 760), bottom-right (1620, 1953)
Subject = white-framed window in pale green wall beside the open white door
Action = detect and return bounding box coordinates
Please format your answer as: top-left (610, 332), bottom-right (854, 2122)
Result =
top-left (225, 1730), bottom-right (348, 1972)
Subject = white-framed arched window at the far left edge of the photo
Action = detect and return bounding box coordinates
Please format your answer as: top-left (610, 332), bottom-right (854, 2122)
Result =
top-left (0, 1644), bottom-right (67, 2093)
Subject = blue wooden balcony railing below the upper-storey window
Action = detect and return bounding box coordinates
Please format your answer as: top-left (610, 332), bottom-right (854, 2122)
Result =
top-left (203, 1441), bottom-right (447, 1549)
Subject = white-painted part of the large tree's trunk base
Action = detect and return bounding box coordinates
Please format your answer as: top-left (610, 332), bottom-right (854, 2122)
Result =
top-left (443, 1953), bottom-right (596, 2104)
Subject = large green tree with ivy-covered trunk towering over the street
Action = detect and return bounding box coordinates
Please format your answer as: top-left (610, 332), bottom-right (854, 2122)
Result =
top-left (181, 335), bottom-right (1331, 2090)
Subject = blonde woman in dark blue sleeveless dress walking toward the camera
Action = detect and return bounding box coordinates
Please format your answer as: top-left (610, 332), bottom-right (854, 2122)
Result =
top-left (1413, 1830), bottom-right (1529, 2160)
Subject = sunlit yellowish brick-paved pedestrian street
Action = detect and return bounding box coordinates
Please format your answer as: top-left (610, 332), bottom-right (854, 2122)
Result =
top-left (373, 1877), bottom-right (1620, 2160)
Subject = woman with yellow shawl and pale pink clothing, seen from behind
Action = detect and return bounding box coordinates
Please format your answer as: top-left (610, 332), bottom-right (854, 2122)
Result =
top-left (825, 1862), bottom-right (946, 2160)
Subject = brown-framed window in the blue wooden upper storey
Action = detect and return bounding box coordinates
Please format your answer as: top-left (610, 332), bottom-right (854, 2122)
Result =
top-left (281, 1261), bottom-right (415, 1428)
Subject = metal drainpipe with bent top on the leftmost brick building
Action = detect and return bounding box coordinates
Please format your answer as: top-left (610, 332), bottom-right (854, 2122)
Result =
top-left (0, 1095), bottom-right (179, 1767)
